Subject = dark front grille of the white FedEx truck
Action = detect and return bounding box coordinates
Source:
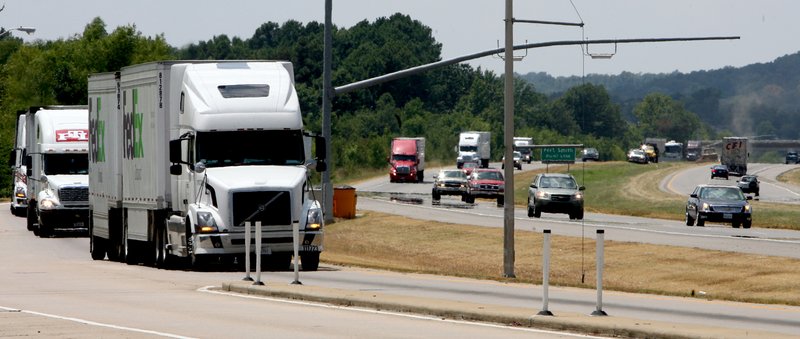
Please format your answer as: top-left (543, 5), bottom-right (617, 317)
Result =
top-left (231, 191), bottom-right (292, 226)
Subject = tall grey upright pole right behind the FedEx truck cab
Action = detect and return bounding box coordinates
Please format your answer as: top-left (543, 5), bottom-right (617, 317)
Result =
top-left (322, 0), bottom-right (334, 223)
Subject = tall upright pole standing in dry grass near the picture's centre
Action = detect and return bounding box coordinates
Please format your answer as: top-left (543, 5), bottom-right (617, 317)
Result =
top-left (503, 0), bottom-right (516, 278)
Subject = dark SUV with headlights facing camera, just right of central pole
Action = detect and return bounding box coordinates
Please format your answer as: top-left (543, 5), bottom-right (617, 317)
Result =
top-left (528, 173), bottom-right (585, 219)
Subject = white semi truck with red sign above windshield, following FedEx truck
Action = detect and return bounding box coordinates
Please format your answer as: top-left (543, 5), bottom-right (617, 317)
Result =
top-left (25, 106), bottom-right (89, 237)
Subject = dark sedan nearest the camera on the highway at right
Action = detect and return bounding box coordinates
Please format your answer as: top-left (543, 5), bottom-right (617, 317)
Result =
top-left (686, 185), bottom-right (753, 228)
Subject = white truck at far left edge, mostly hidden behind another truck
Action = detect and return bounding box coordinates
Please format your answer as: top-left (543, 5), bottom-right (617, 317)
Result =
top-left (8, 110), bottom-right (28, 217)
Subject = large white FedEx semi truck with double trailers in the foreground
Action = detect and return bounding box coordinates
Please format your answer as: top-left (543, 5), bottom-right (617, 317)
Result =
top-left (88, 61), bottom-right (326, 271)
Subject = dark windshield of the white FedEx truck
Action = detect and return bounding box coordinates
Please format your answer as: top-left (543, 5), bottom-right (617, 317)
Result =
top-left (195, 131), bottom-right (305, 167)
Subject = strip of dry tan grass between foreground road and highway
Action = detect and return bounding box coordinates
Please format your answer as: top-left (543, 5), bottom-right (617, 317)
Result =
top-left (322, 212), bottom-right (800, 305)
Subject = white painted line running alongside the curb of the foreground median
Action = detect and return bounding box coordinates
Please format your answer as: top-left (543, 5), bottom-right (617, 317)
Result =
top-left (197, 286), bottom-right (607, 338)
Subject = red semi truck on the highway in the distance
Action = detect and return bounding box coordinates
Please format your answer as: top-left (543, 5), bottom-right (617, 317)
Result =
top-left (389, 138), bottom-right (425, 182)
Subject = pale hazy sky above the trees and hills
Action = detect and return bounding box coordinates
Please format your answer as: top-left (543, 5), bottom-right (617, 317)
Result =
top-left (6, 0), bottom-right (800, 76)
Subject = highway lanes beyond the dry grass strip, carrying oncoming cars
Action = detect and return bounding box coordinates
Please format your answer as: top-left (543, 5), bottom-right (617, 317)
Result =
top-left (355, 163), bottom-right (800, 258)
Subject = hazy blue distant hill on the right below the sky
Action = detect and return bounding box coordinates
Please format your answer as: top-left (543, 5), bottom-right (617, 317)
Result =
top-left (521, 52), bottom-right (800, 139)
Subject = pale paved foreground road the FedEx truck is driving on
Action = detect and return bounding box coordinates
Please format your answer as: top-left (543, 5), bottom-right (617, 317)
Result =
top-left (0, 209), bottom-right (800, 338)
